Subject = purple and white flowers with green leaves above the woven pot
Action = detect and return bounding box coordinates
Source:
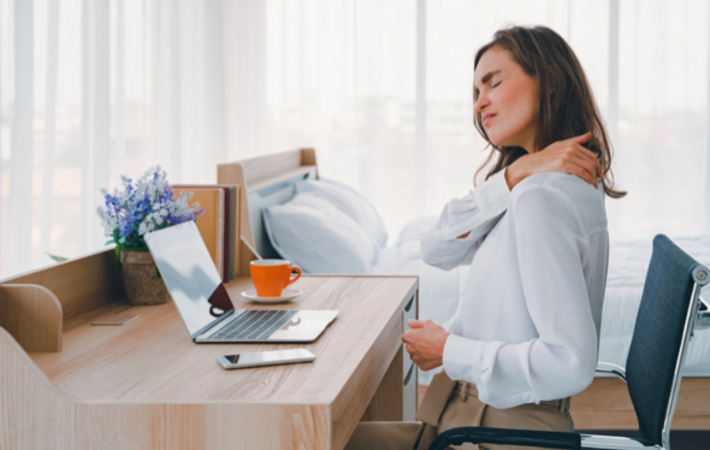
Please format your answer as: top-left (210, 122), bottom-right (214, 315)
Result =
top-left (97, 166), bottom-right (204, 252)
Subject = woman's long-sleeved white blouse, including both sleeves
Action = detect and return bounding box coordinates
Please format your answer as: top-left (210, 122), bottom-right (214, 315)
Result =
top-left (421, 167), bottom-right (609, 408)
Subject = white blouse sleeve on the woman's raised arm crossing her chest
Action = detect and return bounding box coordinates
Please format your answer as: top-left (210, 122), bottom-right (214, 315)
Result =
top-left (421, 169), bottom-right (510, 270)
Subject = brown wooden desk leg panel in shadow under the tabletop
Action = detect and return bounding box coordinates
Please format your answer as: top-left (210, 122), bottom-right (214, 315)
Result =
top-left (360, 346), bottom-right (404, 421)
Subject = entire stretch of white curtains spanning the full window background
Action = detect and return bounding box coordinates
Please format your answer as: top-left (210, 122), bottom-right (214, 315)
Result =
top-left (0, 0), bottom-right (710, 278)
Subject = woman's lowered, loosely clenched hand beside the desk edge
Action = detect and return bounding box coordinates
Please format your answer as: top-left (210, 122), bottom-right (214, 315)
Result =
top-left (402, 319), bottom-right (449, 370)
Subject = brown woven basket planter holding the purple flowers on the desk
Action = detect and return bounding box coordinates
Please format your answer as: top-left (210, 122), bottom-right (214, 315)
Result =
top-left (120, 250), bottom-right (170, 306)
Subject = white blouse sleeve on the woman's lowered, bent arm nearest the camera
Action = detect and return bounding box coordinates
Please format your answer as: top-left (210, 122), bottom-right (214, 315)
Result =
top-left (443, 182), bottom-right (598, 408)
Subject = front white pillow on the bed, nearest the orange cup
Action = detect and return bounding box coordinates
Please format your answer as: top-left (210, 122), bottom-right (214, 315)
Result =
top-left (264, 193), bottom-right (378, 275)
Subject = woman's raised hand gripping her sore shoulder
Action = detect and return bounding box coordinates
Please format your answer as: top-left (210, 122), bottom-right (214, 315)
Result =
top-left (505, 132), bottom-right (604, 190)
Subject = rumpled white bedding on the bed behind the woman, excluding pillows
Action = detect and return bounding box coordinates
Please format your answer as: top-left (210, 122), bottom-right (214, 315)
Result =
top-left (373, 216), bottom-right (710, 385)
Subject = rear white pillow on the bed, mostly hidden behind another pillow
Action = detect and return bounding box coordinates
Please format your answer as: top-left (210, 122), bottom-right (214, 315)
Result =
top-left (296, 179), bottom-right (387, 248)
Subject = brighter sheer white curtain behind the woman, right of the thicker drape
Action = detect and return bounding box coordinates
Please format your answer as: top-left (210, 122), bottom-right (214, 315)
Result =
top-left (252, 0), bottom-right (710, 243)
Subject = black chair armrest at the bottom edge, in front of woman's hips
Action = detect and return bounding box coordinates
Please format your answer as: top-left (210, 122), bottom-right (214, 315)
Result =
top-left (429, 427), bottom-right (581, 450)
